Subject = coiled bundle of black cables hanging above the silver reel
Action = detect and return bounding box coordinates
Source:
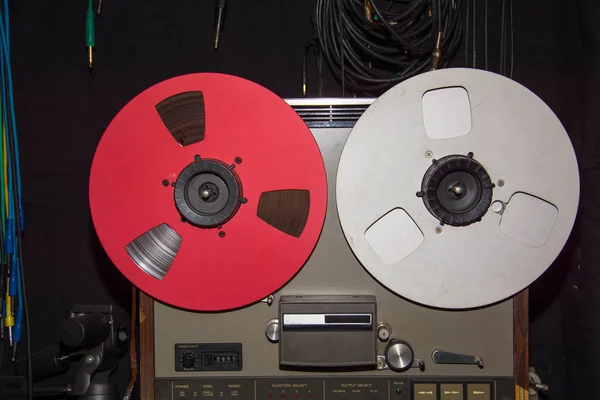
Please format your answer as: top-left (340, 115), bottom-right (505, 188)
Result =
top-left (314, 0), bottom-right (465, 95)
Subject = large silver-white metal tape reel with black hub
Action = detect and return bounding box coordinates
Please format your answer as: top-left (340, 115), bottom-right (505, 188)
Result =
top-left (336, 69), bottom-right (579, 309)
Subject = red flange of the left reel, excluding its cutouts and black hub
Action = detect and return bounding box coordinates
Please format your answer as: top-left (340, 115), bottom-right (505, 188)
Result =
top-left (89, 73), bottom-right (327, 311)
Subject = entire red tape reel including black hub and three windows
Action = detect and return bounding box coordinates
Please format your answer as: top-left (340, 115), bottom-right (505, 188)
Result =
top-left (89, 73), bottom-right (327, 311)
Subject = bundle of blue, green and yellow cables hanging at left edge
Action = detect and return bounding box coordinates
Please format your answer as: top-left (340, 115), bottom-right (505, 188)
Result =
top-left (0, 0), bottom-right (32, 398)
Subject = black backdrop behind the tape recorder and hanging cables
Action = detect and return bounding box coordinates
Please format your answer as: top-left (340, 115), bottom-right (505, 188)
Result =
top-left (2, 0), bottom-right (600, 399)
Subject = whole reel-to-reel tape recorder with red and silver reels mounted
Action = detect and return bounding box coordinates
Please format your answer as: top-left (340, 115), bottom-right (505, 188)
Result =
top-left (90, 69), bottom-right (579, 400)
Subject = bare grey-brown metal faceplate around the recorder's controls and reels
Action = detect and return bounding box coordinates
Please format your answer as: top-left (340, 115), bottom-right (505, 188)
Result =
top-left (154, 99), bottom-right (513, 382)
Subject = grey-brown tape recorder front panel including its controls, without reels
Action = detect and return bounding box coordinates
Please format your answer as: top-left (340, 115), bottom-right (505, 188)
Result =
top-left (154, 99), bottom-right (514, 390)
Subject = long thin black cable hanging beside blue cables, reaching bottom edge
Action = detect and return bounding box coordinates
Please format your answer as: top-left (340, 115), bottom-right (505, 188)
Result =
top-left (7, 102), bottom-right (33, 400)
